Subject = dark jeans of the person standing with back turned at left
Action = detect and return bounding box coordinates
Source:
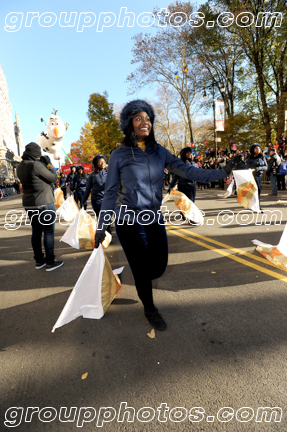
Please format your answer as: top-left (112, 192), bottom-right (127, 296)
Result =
top-left (25, 203), bottom-right (56, 264)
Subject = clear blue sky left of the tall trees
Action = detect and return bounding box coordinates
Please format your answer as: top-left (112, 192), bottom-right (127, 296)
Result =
top-left (0, 0), bottom-right (206, 159)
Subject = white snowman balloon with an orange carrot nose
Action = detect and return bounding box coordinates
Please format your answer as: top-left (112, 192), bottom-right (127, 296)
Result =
top-left (37, 109), bottom-right (69, 160)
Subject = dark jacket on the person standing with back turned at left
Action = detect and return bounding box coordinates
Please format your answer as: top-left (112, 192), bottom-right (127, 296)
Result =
top-left (17, 152), bottom-right (57, 208)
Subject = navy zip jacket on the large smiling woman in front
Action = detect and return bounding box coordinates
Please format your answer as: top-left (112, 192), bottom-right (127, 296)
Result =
top-left (98, 144), bottom-right (231, 233)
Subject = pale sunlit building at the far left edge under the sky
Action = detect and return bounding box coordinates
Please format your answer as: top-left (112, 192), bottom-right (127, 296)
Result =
top-left (0, 66), bottom-right (24, 183)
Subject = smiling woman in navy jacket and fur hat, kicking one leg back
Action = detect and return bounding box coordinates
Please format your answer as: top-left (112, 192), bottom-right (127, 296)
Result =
top-left (95, 100), bottom-right (232, 330)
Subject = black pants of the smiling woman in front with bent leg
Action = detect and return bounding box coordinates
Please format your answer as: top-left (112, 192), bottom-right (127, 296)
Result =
top-left (116, 221), bottom-right (168, 311)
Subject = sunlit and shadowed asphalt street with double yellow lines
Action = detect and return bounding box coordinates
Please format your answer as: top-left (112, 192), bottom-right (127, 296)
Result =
top-left (0, 189), bottom-right (287, 432)
